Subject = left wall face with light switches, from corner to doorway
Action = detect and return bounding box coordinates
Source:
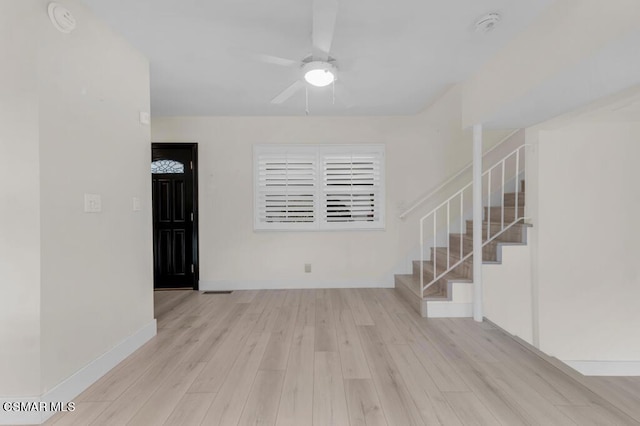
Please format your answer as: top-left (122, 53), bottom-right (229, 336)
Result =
top-left (38, 0), bottom-right (153, 393)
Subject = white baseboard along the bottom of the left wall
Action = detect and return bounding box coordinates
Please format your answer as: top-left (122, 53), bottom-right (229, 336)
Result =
top-left (0, 319), bottom-right (157, 425)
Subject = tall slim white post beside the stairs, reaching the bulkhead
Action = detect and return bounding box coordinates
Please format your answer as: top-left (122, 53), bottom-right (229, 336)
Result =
top-left (473, 124), bottom-right (482, 322)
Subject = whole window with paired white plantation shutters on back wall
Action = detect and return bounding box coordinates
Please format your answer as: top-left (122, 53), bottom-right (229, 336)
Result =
top-left (254, 145), bottom-right (384, 230)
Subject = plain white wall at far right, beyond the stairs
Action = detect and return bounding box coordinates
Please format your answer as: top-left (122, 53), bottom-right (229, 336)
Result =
top-left (527, 122), bottom-right (640, 366)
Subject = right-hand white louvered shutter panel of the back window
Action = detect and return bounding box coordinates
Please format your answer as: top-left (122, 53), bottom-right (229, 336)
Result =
top-left (321, 150), bottom-right (382, 229)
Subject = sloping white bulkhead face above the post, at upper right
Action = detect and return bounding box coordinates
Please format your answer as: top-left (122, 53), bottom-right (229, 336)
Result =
top-left (463, 0), bottom-right (640, 126)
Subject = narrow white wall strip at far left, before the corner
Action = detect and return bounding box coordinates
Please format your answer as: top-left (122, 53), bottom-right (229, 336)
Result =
top-left (0, 1), bottom-right (40, 397)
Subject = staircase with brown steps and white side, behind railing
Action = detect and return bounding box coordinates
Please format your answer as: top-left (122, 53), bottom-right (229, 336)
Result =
top-left (395, 146), bottom-right (530, 318)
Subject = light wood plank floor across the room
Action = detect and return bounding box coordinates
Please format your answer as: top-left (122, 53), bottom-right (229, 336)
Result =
top-left (48, 289), bottom-right (640, 426)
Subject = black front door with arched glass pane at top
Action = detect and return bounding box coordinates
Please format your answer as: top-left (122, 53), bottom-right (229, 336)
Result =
top-left (151, 143), bottom-right (198, 289)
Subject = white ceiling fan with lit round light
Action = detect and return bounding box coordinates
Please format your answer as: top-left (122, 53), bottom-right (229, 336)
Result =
top-left (258, 0), bottom-right (350, 114)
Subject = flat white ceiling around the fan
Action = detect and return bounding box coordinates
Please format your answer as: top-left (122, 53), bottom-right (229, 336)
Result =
top-left (84, 0), bottom-right (553, 116)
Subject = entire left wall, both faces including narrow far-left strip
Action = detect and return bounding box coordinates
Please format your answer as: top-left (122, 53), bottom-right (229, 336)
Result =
top-left (0, 0), bottom-right (154, 397)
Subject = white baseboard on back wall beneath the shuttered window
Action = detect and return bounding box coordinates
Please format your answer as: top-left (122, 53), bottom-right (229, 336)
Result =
top-left (199, 280), bottom-right (394, 291)
